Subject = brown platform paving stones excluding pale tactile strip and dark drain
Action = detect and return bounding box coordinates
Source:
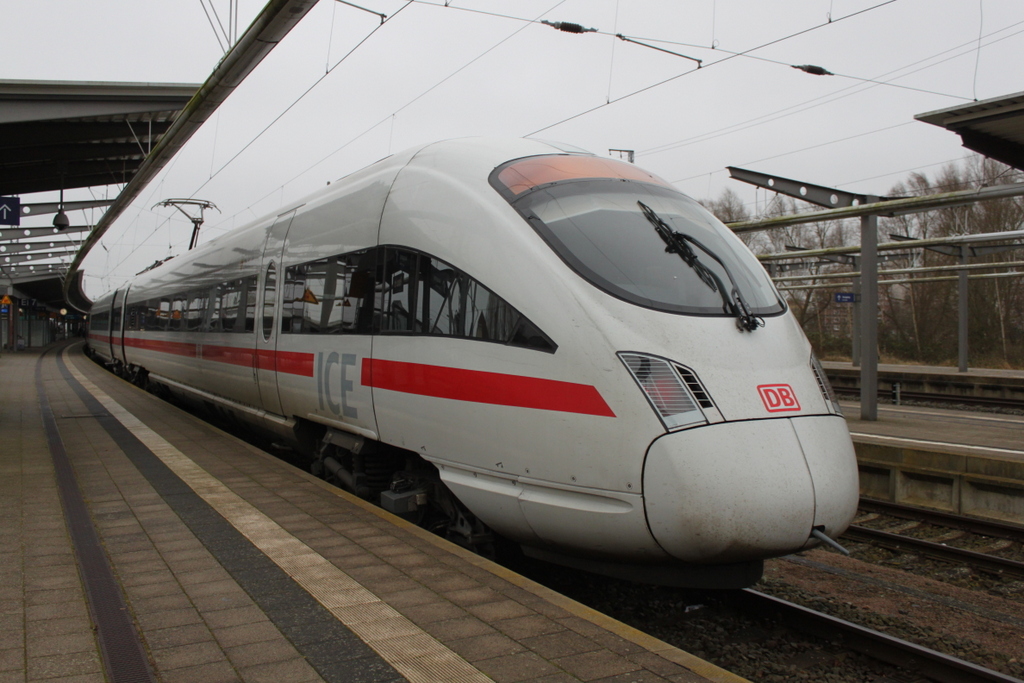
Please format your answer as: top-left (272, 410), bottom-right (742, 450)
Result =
top-left (0, 347), bottom-right (739, 683)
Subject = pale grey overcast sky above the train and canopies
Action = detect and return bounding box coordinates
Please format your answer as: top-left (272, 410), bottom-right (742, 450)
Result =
top-left (0, 0), bottom-right (1024, 297)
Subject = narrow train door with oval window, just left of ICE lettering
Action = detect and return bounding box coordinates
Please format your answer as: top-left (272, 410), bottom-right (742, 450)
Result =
top-left (255, 209), bottom-right (296, 415)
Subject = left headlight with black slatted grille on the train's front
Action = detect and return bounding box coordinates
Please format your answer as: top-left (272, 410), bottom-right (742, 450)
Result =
top-left (618, 351), bottom-right (714, 429)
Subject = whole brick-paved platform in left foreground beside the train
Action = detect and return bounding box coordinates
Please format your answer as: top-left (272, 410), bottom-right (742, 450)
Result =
top-left (0, 343), bottom-right (743, 683)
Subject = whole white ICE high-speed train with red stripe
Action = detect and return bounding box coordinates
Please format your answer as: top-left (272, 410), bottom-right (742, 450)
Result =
top-left (89, 139), bottom-right (858, 587)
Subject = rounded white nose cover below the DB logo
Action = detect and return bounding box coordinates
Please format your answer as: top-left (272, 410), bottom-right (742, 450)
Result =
top-left (644, 416), bottom-right (858, 563)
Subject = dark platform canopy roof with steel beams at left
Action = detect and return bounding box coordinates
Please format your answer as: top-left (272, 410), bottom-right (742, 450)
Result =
top-left (0, 80), bottom-right (200, 308)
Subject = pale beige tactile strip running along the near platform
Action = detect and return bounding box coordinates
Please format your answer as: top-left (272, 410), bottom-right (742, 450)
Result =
top-left (63, 349), bottom-right (492, 683)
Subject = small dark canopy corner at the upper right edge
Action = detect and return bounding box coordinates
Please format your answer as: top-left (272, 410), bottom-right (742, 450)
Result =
top-left (914, 92), bottom-right (1024, 170)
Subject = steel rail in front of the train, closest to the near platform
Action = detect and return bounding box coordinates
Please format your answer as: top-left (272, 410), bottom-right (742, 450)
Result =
top-left (725, 588), bottom-right (1021, 683)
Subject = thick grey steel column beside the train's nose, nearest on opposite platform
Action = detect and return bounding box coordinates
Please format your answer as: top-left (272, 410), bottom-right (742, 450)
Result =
top-left (860, 206), bottom-right (879, 422)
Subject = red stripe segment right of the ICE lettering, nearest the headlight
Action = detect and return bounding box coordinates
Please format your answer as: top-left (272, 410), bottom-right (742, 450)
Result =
top-left (361, 358), bottom-right (615, 418)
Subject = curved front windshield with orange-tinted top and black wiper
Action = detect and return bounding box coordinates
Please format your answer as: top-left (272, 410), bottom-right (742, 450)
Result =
top-left (493, 156), bottom-right (784, 315)
